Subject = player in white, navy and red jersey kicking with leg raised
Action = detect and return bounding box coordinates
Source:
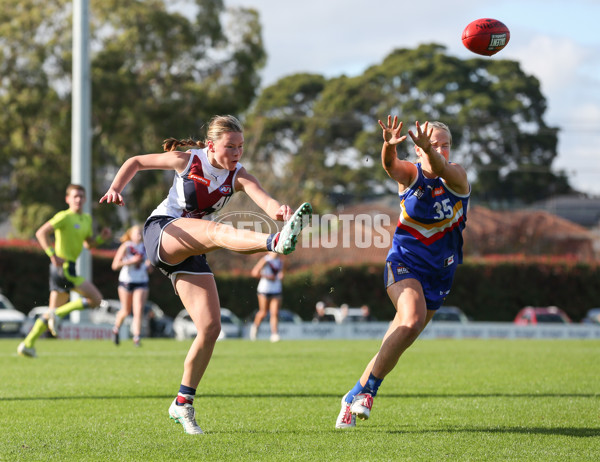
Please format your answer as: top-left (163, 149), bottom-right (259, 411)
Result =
top-left (100, 116), bottom-right (312, 434)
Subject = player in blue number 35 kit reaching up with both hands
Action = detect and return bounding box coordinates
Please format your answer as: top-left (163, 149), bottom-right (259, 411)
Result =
top-left (335, 116), bottom-right (471, 428)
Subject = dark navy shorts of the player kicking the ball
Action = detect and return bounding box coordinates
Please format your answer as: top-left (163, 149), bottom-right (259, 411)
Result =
top-left (144, 216), bottom-right (213, 287)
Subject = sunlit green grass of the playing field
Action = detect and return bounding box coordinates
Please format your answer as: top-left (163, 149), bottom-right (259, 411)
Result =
top-left (0, 340), bottom-right (600, 462)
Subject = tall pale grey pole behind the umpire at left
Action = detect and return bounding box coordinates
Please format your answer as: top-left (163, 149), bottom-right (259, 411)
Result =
top-left (71, 0), bottom-right (92, 281)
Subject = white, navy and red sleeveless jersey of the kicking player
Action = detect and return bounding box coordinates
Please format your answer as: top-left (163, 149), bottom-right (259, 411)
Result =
top-left (151, 149), bottom-right (242, 218)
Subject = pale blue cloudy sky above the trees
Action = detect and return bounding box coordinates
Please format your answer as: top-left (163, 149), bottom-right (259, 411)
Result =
top-left (225, 0), bottom-right (600, 196)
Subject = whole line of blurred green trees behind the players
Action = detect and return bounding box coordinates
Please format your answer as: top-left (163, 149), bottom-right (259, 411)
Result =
top-left (0, 0), bottom-right (571, 238)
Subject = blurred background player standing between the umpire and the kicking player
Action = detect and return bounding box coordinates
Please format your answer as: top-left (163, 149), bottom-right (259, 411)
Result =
top-left (112, 225), bottom-right (152, 346)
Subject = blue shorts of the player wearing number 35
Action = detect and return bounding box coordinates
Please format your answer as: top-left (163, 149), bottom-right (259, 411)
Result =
top-left (383, 260), bottom-right (454, 310)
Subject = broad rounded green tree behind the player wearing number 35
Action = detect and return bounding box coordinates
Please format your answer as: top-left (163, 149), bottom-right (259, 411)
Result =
top-left (248, 44), bottom-right (570, 207)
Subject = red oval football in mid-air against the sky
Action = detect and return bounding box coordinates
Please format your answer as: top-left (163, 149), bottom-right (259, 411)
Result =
top-left (462, 18), bottom-right (510, 56)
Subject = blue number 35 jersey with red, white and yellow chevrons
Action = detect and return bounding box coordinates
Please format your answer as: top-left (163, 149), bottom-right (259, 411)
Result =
top-left (387, 164), bottom-right (469, 272)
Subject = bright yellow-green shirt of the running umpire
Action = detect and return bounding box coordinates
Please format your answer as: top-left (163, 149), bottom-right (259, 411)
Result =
top-left (49, 210), bottom-right (92, 261)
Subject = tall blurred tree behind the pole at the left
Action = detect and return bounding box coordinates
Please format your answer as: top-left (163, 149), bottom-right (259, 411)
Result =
top-left (0, 0), bottom-right (266, 237)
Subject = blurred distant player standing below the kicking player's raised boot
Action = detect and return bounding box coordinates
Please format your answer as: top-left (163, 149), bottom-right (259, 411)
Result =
top-left (250, 253), bottom-right (283, 342)
